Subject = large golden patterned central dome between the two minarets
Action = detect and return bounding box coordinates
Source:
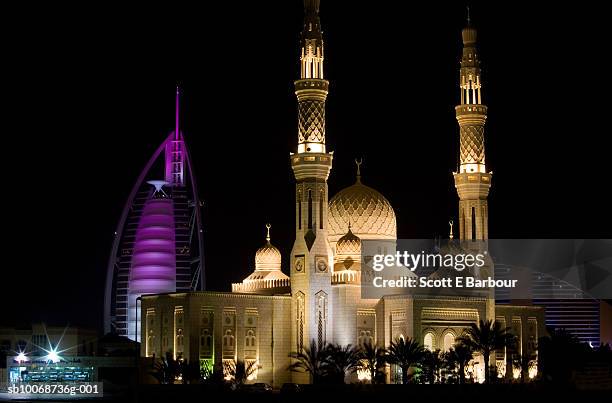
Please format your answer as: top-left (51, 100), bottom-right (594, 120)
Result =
top-left (327, 179), bottom-right (397, 243)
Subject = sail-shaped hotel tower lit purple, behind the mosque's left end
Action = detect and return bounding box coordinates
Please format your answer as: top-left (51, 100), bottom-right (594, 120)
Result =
top-left (104, 88), bottom-right (205, 340)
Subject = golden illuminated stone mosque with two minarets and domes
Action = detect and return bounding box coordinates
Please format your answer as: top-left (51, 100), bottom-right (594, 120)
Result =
top-left (136, 0), bottom-right (545, 387)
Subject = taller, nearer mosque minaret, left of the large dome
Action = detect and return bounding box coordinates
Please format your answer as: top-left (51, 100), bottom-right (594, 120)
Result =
top-left (291, 0), bottom-right (333, 364)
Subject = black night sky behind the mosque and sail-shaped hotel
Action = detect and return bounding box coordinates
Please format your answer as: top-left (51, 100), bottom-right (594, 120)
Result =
top-left (0, 0), bottom-right (612, 327)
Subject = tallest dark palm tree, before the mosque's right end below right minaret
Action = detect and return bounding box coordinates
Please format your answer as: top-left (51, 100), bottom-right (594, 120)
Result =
top-left (460, 319), bottom-right (513, 383)
